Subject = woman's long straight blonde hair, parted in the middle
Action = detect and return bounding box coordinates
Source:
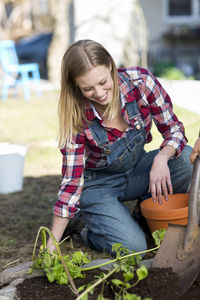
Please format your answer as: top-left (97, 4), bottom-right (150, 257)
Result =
top-left (58, 40), bottom-right (119, 147)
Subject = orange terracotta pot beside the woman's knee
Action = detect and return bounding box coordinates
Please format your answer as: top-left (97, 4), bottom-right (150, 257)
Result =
top-left (140, 194), bottom-right (189, 232)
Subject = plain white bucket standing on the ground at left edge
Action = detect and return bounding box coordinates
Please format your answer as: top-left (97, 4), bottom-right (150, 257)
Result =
top-left (0, 143), bottom-right (27, 194)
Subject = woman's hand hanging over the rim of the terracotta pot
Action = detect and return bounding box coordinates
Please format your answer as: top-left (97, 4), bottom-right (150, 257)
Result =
top-left (149, 146), bottom-right (175, 204)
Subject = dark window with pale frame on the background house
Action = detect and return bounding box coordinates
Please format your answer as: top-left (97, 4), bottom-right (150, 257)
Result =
top-left (163, 0), bottom-right (200, 24)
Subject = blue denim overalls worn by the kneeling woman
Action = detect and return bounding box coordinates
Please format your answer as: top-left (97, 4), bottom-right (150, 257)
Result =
top-left (80, 101), bottom-right (192, 253)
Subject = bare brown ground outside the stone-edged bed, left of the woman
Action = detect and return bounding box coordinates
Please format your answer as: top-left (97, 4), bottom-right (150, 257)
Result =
top-left (0, 175), bottom-right (102, 272)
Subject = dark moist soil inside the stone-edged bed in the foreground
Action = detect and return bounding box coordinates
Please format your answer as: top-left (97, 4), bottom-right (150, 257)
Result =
top-left (17, 269), bottom-right (200, 300)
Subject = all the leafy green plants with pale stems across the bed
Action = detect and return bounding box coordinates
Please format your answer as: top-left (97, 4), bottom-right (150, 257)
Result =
top-left (29, 226), bottom-right (165, 300)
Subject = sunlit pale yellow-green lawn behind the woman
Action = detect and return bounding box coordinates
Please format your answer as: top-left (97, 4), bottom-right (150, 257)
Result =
top-left (0, 86), bottom-right (200, 176)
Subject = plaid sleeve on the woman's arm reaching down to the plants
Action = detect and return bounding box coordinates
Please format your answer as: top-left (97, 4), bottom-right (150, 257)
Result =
top-left (53, 138), bottom-right (85, 218)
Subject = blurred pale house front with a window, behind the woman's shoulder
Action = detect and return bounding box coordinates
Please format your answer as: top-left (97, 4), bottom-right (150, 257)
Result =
top-left (138, 0), bottom-right (200, 79)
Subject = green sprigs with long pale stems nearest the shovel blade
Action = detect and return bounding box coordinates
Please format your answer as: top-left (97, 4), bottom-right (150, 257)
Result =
top-left (76, 229), bottom-right (166, 300)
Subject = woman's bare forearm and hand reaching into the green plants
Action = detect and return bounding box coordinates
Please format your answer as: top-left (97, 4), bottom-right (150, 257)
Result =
top-left (47, 215), bottom-right (69, 251)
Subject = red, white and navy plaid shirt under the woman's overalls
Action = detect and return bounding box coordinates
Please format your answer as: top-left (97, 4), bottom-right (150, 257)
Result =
top-left (54, 67), bottom-right (187, 218)
